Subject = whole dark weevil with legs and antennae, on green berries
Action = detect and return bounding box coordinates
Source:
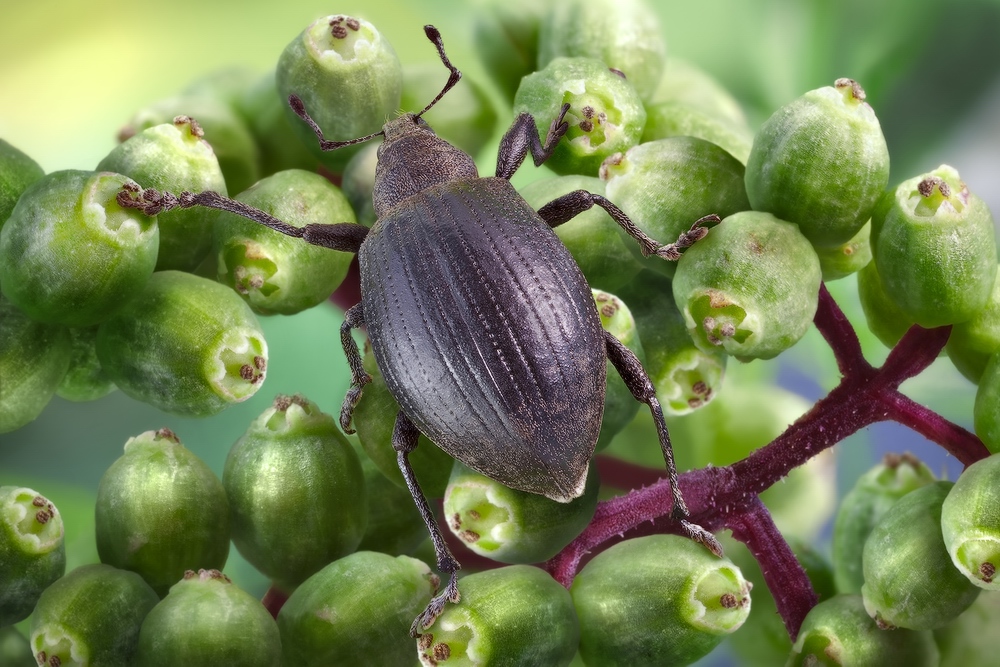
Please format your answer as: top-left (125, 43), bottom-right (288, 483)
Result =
top-left (119, 26), bottom-right (721, 636)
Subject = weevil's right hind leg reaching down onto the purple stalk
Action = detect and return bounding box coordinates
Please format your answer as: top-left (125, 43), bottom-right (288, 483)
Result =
top-left (604, 331), bottom-right (722, 556)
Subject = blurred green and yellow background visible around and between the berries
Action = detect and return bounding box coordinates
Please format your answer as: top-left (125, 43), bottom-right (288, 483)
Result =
top-left (0, 0), bottom-right (1000, 664)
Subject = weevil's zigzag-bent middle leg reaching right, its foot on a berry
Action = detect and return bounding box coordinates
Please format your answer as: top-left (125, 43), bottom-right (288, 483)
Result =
top-left (538, 190), bottom-right (720, 261)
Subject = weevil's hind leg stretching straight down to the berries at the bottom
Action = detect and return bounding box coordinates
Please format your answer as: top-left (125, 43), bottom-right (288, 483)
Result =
top-left (392, 411), bottom-right (462, 637)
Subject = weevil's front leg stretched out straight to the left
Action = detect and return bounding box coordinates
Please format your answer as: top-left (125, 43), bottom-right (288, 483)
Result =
top-left (117, 188), bottom-right (368, 253)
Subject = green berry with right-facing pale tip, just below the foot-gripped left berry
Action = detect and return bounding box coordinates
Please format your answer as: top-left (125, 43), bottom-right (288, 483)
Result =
top-left (97, 271), bottom-right (267, 415)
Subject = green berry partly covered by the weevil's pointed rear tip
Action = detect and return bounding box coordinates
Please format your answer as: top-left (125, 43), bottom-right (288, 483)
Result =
top-left (444, 462), bottom-right (600, 564)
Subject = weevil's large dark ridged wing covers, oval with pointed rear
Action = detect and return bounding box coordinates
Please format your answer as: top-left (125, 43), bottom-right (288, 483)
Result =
top-left (358, 178), bottom-right (606, 502)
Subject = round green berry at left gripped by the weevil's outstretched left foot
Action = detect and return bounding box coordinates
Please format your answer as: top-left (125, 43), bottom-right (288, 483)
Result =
top-left (0, 170), bottom-right (159, 327)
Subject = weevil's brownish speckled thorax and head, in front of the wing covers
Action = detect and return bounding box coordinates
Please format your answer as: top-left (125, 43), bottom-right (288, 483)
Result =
top-left (372, 114), bottom-right (479, 217)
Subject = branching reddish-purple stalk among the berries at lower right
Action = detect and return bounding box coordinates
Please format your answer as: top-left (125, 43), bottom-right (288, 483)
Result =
top-left (547, 286), bottom-right (989, 637)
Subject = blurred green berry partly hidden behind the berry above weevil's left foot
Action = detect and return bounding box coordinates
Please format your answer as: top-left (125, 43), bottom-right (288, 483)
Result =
top-left (118, 91), bottom-right (260, 194)
